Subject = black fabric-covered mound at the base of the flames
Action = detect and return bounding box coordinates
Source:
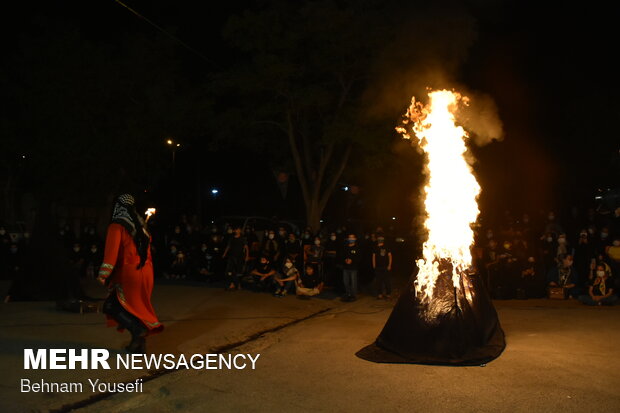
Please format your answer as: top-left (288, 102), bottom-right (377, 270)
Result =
top-left (356, 273), bottom-right (506, 366)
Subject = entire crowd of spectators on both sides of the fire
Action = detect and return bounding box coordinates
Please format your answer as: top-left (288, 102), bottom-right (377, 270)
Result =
top-left (0, 204), bottom-right (620, 305)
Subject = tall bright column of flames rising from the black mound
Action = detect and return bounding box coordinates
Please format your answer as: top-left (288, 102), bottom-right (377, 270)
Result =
top-left (396, 90), bottom-right (480, 301)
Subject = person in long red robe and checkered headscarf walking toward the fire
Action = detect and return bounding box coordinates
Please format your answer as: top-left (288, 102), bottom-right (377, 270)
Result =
top-left (97, 194), bottom-right (164, 353)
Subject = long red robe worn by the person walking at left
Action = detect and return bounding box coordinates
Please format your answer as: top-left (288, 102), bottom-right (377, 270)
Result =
top-left (99, 223), bottom-right (164, 334)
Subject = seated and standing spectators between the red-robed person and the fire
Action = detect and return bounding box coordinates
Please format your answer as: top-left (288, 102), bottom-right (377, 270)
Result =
top-left (154, 222), bottom-right (392, 301)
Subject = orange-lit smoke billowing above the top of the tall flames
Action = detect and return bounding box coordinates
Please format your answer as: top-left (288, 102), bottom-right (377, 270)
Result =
top-left (365, 2), bottom-right (503, 146)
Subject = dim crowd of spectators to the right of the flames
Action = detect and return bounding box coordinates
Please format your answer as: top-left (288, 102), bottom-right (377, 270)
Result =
top-left (474, 208), bottom-right (620, 305)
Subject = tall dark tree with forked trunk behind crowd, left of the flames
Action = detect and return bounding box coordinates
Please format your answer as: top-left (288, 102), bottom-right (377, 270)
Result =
top-left (213, 0), bottom-right (389, 230)
